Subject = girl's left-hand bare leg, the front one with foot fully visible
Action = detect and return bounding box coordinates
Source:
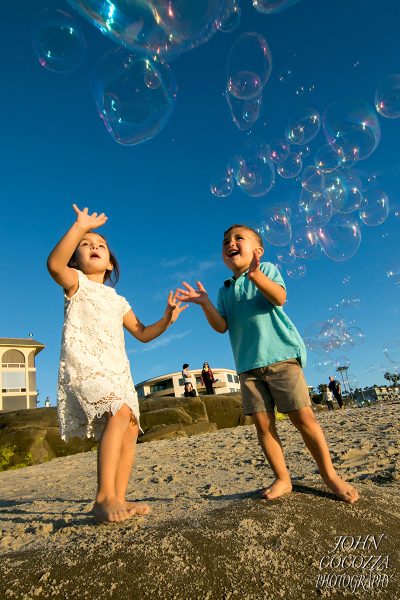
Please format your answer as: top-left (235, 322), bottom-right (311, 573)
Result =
top-left (93, 404), bottom-right (138, 522)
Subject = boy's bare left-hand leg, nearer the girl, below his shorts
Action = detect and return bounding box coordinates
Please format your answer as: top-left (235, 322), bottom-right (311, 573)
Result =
top-left (252, 412), bottom-right (292, 500)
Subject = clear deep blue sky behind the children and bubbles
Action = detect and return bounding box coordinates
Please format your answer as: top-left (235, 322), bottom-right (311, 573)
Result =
top-left (0, 0), bottom-right (400, 403)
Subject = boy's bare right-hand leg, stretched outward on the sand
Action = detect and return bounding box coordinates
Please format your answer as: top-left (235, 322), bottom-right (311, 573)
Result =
top-left (288, 406), bottom-right (358, 504)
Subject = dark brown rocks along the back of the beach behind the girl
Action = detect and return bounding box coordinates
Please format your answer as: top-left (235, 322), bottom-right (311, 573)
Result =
top-left (0, 394), bottom-right (247, 470)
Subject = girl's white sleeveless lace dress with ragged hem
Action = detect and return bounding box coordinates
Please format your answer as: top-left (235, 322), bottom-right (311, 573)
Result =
top-left (57, 270), bottom-right (139, 441)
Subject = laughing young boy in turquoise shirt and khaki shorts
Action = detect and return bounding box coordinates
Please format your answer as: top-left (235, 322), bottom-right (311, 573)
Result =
top-left (178, 225), bottom-right (358, 504)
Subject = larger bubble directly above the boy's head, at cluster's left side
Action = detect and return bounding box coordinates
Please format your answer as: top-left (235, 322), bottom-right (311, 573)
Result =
top-left (236, 144), bottom-right (275, 198)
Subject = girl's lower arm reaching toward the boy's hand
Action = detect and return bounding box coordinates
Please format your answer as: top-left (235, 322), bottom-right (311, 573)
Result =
top-left (124, 290), bottom-right (188, 343)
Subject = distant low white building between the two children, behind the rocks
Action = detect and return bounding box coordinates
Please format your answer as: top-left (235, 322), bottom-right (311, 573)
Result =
top-left (135, 368), bottom-right (240, 400)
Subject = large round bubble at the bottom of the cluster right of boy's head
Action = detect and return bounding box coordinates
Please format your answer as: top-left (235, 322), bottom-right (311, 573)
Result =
top-left (316, 214), bottom-right (361, 262)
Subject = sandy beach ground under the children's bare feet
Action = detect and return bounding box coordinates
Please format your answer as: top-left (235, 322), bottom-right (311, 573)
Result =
top-left (0, 403), bottom-right (400, 600)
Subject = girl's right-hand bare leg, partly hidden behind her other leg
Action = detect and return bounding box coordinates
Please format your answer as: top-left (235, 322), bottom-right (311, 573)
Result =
top-left (115, 415), bottom-right (150, 515)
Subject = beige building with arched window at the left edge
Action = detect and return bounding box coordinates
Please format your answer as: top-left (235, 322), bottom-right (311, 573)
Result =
top-left (0, 337), bottom-right (45, 412)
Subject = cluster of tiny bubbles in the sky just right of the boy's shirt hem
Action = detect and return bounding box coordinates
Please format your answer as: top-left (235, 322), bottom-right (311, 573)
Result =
top-left (303, 313), bottom-right (365, 373)
